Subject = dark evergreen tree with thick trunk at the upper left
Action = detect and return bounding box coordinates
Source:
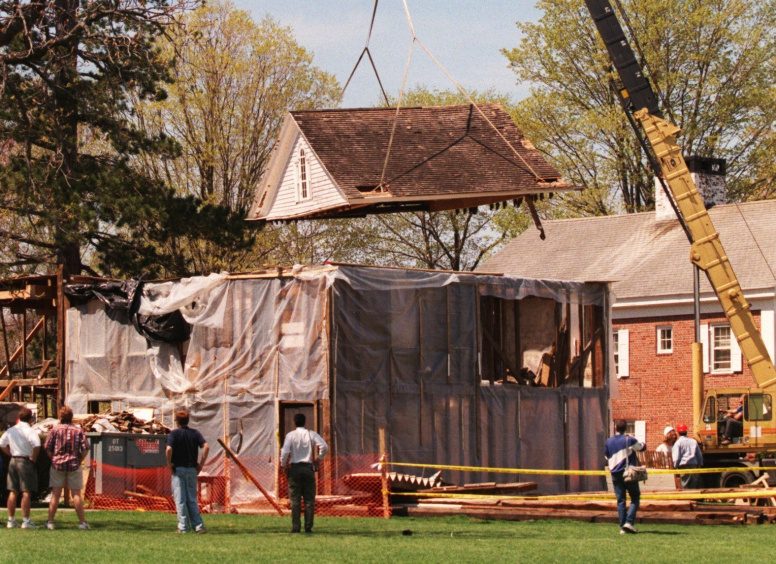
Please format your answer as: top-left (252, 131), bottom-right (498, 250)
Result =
top-left (0, 0), bottom-right (215, 274)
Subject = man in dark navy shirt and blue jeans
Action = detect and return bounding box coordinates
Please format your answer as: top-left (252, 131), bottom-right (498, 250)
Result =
top-left (165, 409), bottom-right (210, 533)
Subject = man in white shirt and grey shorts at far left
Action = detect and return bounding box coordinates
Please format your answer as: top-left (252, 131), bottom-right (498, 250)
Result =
top-left (0, 407), bottom-right (40, 529)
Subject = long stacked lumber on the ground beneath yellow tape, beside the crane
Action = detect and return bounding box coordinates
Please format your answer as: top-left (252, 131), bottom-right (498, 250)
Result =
top-left (404, 489), bottom-right (776, 525)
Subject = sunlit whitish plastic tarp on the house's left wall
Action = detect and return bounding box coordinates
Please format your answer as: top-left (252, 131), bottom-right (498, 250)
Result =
top-left (67, 268), bottom-right (328, 503)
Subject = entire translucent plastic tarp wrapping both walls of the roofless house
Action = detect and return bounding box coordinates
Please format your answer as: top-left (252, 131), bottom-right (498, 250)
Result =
top-left (66, 266), bottom-right (606, 503)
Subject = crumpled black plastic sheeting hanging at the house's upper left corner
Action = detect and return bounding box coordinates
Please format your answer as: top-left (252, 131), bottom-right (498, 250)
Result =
top-left (64, 279), bottom-right (191, 343)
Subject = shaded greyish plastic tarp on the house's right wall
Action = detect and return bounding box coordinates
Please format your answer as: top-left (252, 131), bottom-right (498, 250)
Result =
top-left (332, 268), bottom-right (607, 493)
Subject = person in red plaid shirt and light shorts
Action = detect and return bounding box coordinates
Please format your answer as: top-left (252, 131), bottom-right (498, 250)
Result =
top-left (45, 405), bottom-right (89, 531)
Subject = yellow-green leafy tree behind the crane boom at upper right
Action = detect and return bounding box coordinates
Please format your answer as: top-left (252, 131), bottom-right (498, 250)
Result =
top-left (504, 0), bottom-right (776, 215)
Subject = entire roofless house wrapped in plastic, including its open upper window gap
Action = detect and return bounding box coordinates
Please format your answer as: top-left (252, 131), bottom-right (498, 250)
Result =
top-left (57, 265), bottom-right (609, 504)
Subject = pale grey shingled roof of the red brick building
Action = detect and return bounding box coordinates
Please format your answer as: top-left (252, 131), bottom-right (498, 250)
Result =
top-left (478, 200), bottom-right (776, 299)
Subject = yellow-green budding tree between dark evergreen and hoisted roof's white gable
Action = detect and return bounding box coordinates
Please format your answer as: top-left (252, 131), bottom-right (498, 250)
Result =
top-left (138, 1), bottom-right (340, 271)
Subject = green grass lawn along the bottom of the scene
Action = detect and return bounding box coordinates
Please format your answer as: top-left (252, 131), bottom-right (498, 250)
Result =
top-left (0, 510), bottom-right (776, 564)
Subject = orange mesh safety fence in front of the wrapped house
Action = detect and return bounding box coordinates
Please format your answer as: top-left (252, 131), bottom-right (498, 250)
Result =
top-left (84, 454), bottom-right (398, 517)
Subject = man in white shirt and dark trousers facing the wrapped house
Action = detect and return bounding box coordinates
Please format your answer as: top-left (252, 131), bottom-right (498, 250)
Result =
top-left (280, 413), bottom-right (329, 533)
